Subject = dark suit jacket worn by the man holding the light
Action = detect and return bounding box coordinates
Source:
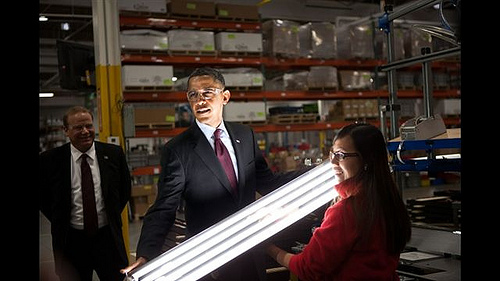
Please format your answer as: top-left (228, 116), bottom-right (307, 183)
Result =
top-left (137, 122), bottom-right (308, 281)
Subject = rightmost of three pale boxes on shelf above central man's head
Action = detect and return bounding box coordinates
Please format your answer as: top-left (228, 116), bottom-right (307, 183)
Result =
top-left (215, 32), bottom-right (262, 53)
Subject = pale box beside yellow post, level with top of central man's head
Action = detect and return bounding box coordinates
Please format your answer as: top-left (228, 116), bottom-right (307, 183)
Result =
top-left (122, 65), bottom-right (174, 89)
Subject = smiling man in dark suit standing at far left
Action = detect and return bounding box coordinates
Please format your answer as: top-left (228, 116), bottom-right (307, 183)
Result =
top-left (39, 106), bottom-right (131, 281)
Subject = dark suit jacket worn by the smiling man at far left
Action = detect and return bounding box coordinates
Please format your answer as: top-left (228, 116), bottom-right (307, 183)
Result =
top-left (39, 141), bottom-right (131, 270)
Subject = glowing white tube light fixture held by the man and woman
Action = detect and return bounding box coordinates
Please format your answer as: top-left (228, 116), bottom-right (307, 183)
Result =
top-left (127, 161), bottom-right (338, 281)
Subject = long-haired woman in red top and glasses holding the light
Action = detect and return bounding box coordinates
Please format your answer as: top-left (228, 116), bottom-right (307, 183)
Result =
top-left (267, 123), bottom-right (411, 281)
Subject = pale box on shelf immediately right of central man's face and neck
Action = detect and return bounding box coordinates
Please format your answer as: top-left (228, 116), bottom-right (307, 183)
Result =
top-left (224, 101), bottom-right (266, 122)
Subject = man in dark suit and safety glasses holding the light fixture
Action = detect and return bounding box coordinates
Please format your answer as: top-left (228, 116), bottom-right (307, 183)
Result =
top-left (122, 67), bottom-right (304, 281)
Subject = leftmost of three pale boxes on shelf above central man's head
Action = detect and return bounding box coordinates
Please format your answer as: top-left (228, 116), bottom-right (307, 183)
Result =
top-left (120, 29), bottom-right (168, 51)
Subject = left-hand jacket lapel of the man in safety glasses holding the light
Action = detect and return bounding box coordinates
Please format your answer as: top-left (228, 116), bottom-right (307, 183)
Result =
top-left (191, 124), bottom-right (231, 196)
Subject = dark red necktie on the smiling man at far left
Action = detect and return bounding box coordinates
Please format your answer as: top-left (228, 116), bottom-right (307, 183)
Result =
top-left (81, 154), bottom-right (98, 235)
